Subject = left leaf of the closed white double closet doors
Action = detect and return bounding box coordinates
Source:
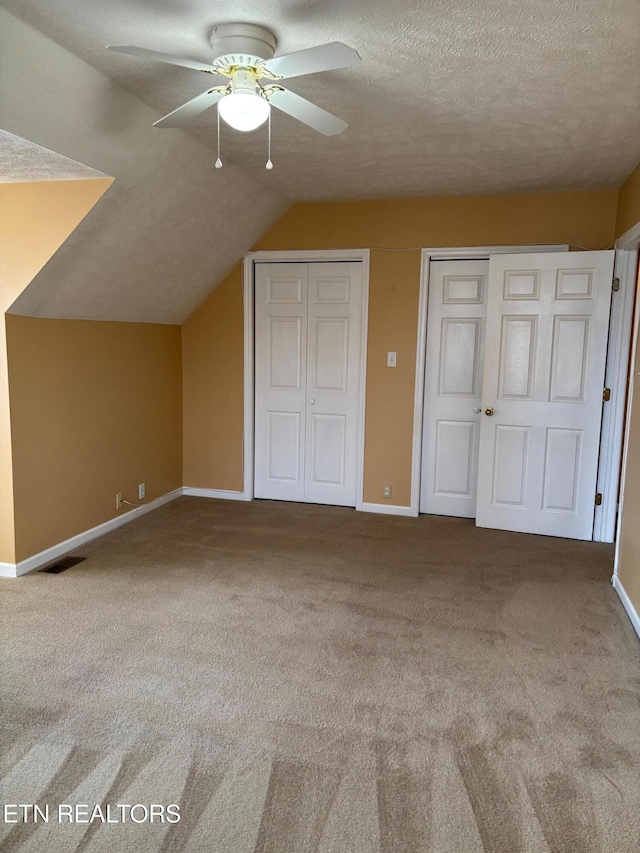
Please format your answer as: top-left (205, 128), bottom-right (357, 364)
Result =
top-left (254, 264), bottom-right (308, 501)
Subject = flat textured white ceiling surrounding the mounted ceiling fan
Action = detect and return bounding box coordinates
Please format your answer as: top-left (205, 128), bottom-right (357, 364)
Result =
top-left (4, 0), bottom-right (640, 200)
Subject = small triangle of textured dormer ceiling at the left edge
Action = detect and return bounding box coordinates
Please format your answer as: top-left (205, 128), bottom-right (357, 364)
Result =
top-left (0, 130), bottom-right (109, 184)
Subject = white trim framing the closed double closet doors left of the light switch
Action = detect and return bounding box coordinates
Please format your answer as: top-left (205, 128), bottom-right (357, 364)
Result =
top-left (242, 249), bottom-right (370, 510)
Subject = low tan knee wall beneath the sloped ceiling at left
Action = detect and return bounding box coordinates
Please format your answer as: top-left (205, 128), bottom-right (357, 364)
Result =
top-left (6, 315), bottom-right (182, 561)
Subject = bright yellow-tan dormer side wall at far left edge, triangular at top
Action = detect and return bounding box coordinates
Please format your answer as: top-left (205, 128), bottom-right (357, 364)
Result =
top-left (0, 178), bottom-right (112, 563)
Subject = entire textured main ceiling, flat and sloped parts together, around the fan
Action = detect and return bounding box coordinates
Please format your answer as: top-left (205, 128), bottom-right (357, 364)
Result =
top-left (0, 0), bottom-right (640, 322)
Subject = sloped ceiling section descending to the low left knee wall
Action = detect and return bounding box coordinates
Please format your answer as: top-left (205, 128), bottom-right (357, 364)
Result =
top-left (0, 9), bottom-right (288, 323)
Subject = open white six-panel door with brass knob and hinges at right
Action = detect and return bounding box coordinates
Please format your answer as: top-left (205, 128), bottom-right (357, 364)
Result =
top-left (476, 251), bottom-right (614, 539)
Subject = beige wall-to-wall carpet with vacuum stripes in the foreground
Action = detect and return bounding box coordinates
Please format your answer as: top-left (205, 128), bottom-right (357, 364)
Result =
top-left (0, 498), bottom-right (640, 853)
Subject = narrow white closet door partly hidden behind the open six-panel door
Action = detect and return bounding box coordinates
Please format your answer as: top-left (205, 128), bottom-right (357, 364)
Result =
top-left (420, 260), bottom-right (489, 518)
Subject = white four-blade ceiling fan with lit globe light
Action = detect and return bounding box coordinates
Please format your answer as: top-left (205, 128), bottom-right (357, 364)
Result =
top-left (108, 23), bottom-right (362, 136)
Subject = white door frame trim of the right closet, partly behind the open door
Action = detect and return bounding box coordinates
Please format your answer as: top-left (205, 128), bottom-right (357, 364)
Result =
top-left (410, 243), bottom-right (569, 516)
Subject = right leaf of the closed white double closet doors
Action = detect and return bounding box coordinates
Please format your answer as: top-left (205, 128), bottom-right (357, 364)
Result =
top-left (304, 262), bottom-right (362, 506)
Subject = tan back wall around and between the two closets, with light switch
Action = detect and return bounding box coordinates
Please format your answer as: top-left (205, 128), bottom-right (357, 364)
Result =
top-left (183, 191), bottom-right (617, 506)
